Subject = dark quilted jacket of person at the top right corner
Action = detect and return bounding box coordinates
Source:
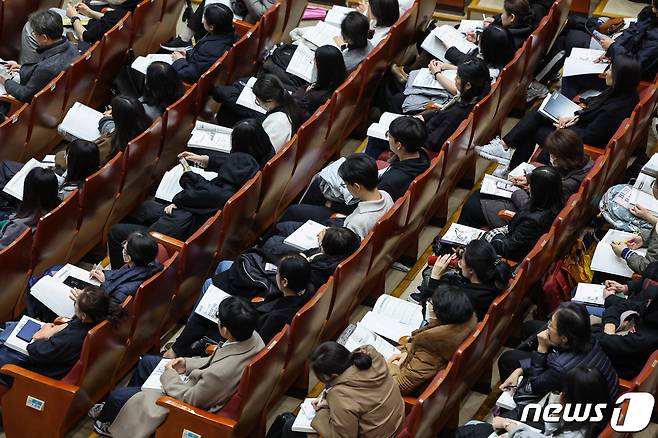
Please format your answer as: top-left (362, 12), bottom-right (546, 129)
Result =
top-left (606, 6), bottom-right (658, 81)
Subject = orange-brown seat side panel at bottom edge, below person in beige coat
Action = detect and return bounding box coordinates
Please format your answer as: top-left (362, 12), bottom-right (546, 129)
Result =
top-left (156, 396), bottom-right (237, 438)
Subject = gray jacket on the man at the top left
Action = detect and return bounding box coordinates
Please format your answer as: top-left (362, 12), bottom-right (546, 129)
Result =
top-left (5, 39), bottom-right (80, 102)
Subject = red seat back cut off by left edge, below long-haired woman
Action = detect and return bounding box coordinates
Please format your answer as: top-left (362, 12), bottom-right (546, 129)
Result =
top-left (0, 229), bottom-right (32, 322)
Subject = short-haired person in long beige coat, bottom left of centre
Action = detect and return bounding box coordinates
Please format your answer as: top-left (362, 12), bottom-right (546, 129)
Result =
top-left (89, 297), bottom-right (265, 438)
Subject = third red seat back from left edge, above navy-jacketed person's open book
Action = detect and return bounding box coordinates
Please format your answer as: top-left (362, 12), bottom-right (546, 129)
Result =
top-left (70, 152), bottom-right (123, 260)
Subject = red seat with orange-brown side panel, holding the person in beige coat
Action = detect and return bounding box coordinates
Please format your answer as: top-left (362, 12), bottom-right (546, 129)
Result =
top-left (155, 326), bottom-right (288, 438)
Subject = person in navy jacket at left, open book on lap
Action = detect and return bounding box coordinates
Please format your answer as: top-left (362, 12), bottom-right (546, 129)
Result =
top-left (24, 233), bottom-right (162, 321)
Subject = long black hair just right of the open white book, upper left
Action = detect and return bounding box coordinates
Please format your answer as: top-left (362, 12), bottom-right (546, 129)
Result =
top-left (112, 96), bottom-right (151, 155)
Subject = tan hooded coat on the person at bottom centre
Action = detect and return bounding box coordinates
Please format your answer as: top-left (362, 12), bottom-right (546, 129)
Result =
top-left (311, 345), bottom-right (404, 438)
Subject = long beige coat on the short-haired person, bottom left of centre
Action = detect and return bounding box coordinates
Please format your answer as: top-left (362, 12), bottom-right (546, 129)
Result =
top-left (110, 332), bottom-right (265, 438)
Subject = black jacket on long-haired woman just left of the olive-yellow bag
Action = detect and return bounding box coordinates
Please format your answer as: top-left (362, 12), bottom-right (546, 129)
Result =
top-left (491, 208), bottom-right (556, 262)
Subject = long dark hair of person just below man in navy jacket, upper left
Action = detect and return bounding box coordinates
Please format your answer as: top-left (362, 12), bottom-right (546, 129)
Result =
top-left (142, 61), bottom-right (185, 114)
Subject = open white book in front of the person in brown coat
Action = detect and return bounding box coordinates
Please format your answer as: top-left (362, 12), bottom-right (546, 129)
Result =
top-left (361, 295), bottom-right (423, 342)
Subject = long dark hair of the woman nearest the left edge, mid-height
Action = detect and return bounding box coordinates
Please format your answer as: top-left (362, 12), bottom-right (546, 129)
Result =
top-left (16, 167), bottom-right (61, 218)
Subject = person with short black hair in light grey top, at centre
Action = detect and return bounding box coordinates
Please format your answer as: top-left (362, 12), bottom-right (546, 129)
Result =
top-left (274, 154), bottom-right (393, 240)
